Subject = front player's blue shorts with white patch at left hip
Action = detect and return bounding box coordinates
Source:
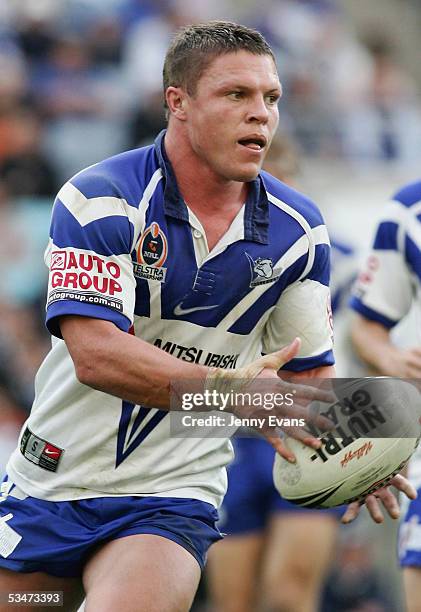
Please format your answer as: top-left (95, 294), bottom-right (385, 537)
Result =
top-left (0, 478), bottom-right (222, 577)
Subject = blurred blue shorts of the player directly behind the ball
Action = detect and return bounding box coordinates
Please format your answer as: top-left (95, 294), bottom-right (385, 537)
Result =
top-left (218, 437), bottom-right (344, 535)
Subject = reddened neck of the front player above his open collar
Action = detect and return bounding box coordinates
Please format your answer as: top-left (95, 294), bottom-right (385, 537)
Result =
top-left (165, 124), bottom-right (248, 218)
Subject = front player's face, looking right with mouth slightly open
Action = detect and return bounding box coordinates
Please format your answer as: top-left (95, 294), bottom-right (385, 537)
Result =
top-left (182, 51), bottom-right (282, 181)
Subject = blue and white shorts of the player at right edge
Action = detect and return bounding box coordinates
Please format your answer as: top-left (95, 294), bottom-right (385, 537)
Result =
top-left (398, 487), bottom-right (421, 567)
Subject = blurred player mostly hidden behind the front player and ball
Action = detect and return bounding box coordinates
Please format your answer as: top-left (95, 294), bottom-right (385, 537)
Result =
top-left (207, 133), bottom-right (355, 612)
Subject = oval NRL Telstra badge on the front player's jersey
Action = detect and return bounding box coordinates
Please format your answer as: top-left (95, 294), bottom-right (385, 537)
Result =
top-left (134, 221), bottom-right (168, 283)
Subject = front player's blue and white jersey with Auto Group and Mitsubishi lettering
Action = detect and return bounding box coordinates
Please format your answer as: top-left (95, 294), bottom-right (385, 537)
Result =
top-left (8, 133), bottom-right (333, 506)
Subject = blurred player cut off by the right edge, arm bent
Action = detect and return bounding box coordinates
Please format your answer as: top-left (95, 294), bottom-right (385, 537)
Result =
top-left (351, 180), bottom-right (421, 612)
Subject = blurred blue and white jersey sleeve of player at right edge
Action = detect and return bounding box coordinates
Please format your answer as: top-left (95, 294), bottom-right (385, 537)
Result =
top-left (350, 202), bottom-right (414, 328)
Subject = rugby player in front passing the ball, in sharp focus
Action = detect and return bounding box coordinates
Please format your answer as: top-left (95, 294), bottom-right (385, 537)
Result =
top-left (0, 22), bottom-right (415, 612)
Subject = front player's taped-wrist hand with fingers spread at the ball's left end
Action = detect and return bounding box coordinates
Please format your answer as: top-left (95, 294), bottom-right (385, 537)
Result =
top-left (206, 338), bottom-right (335, 463)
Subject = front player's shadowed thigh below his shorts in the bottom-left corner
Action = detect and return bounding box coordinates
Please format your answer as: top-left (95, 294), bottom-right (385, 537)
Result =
top-left (0, 568), bottom-right (84, 612)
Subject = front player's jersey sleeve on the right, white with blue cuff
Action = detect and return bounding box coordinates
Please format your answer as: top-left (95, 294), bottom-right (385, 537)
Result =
top-left (263, 225), bottom-right (334, 372)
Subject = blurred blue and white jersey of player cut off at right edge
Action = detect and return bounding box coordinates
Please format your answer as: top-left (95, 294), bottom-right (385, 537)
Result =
top-left (350, 181), bottom-right (421, 478)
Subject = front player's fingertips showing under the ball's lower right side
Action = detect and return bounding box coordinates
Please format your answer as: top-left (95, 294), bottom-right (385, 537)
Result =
top-left (341, 474), bottom-right (417, 524)
